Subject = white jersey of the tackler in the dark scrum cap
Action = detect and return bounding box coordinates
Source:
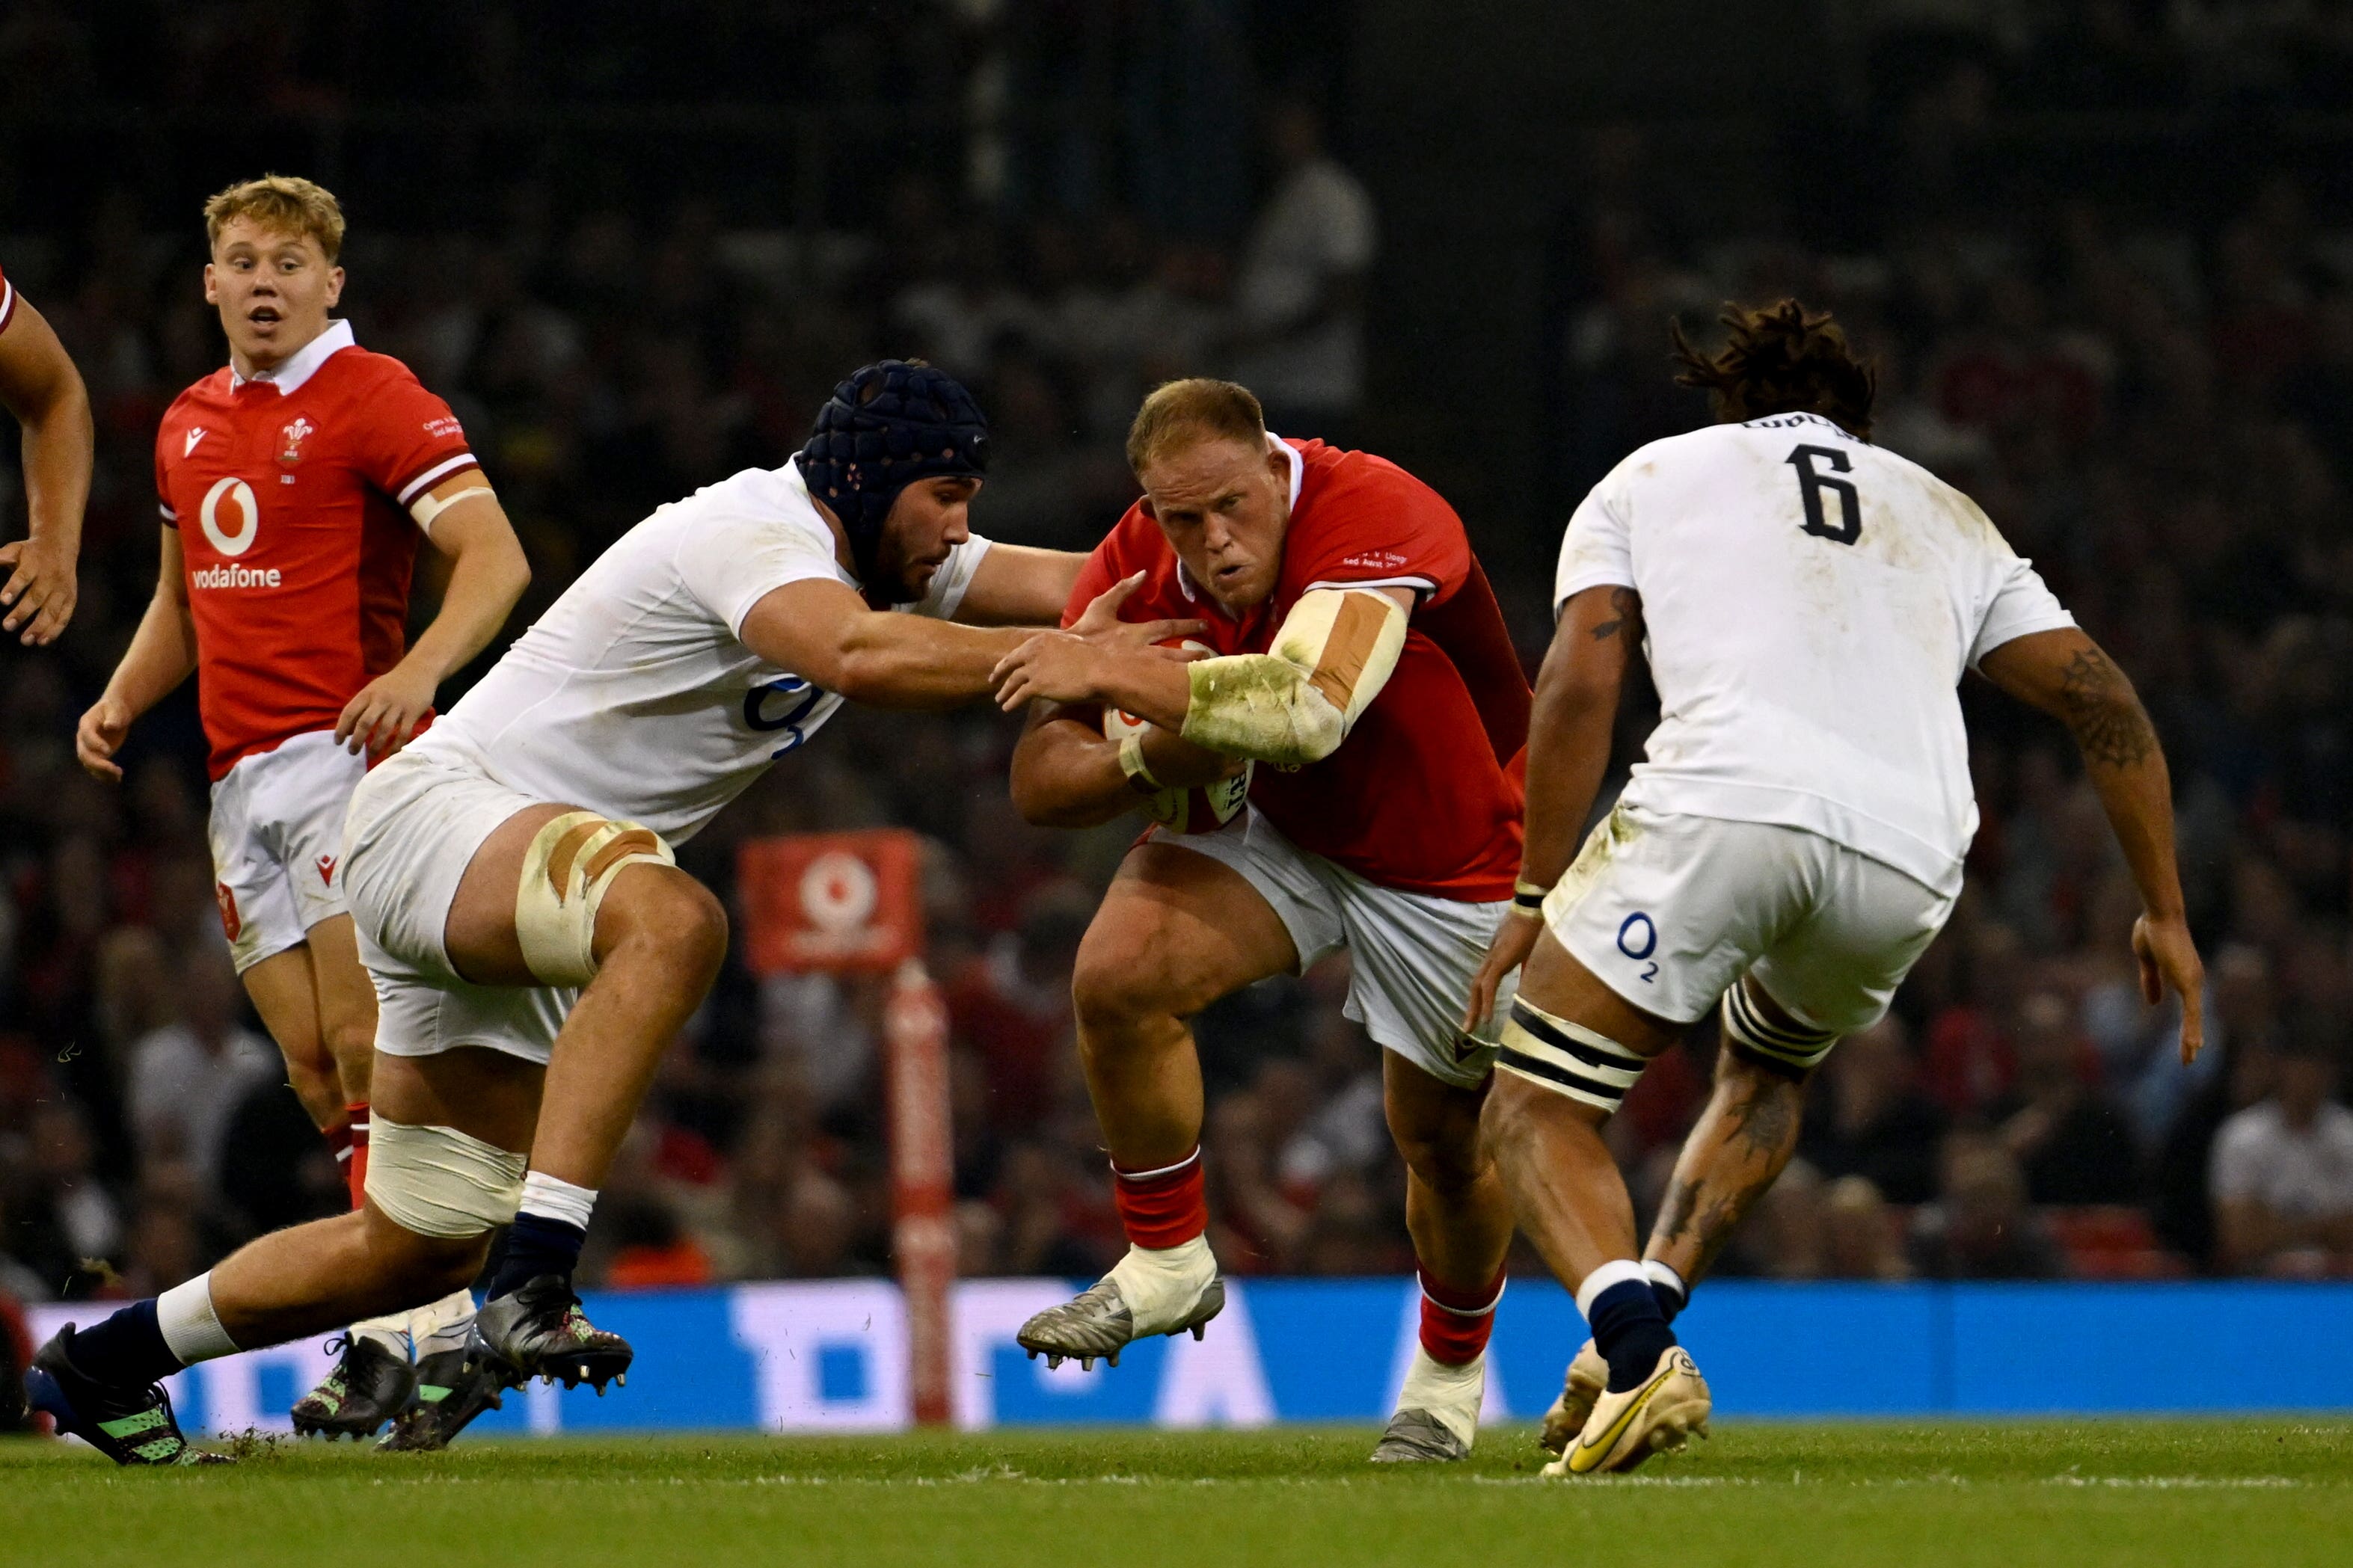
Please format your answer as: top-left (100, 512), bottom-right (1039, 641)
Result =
top-left (412, 463), bottom-right (988, 844)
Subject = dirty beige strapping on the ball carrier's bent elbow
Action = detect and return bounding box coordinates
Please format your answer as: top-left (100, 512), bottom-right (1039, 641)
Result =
top-left (1179, 588), bottom-right (1405, 766)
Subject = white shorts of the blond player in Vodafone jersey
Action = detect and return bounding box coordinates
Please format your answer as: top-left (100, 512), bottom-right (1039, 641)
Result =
top-left (205, 729), bottom-right (367, 976)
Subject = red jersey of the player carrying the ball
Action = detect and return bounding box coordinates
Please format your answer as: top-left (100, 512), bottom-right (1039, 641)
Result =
top-left (1064, 442), bottom-right (1530, 903)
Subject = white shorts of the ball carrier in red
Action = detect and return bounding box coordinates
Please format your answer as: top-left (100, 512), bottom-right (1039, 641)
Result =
top-left (1150, 806), bottom-right (1518, 1089)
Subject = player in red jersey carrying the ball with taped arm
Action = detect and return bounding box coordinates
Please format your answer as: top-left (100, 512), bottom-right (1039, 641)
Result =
top-left (998, 381), bottom-right (1530, 1463)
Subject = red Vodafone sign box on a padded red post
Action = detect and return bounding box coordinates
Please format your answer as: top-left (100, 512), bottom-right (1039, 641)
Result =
top-left (737, 828), bottom-right (955, 1427)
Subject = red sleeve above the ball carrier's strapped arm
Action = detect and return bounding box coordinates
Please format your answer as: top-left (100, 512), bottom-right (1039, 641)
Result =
top-left (1283, 454), bottom-right (1470, 604)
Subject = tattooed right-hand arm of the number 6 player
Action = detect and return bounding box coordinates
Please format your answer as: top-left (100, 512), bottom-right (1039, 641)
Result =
top-left (1977, 627), bottom-right (2205, 1063)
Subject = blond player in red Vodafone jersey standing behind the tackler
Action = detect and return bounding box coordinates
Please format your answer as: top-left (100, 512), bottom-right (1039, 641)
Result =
top-left (78, 174), bottom-right (530, 1439)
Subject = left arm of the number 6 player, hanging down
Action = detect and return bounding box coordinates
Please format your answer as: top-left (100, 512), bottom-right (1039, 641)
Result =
top-left (1464, 585), bottom-right (1642, 1030)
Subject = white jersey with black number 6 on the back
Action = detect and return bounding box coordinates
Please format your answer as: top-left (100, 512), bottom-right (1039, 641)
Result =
top-left (1553, 413), bottom-right (2076, 894)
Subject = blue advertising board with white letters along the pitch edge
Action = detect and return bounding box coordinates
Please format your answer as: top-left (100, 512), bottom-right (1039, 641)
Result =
top-left (33, 1279), bottom-right (2353, 1436)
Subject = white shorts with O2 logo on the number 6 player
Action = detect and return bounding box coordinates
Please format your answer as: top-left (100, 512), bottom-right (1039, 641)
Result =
top-left (1544, 802), bottom-right (1953, 1034)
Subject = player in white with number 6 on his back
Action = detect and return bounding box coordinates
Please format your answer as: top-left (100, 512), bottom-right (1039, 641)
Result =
top-left (1470, 301), bottom-right (2203, 1476)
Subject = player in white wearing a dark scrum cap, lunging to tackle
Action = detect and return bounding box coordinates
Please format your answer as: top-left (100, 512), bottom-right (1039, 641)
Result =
top-left (26, 360), bottom-right (1200, 1465)
